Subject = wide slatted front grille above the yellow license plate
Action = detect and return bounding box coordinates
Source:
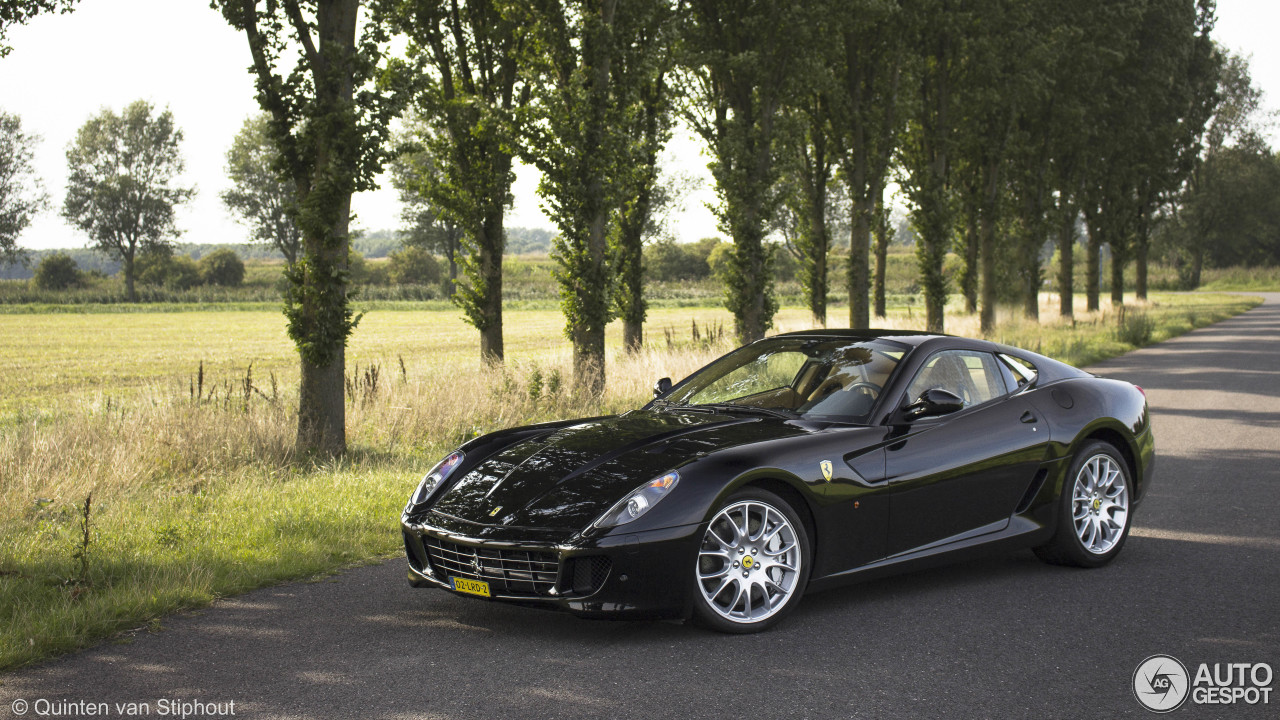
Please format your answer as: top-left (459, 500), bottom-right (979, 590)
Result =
top-left (422, 536), bottom-right (559, 596)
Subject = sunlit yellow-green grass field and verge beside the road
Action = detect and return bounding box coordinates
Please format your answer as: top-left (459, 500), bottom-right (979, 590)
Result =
top-left (0, 289), bottom-right (1254, 669)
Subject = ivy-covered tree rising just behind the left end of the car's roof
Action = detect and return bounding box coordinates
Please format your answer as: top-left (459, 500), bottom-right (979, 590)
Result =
top-left (680, 0), bottom-right (820, 343)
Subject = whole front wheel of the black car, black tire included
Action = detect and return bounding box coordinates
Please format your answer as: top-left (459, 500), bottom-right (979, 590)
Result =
top-left (690, 488), bottom-right (810, 633)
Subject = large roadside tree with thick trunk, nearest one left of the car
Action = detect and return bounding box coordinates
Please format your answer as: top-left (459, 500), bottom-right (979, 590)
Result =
top-left (214, 0), bottom-right (399, 455)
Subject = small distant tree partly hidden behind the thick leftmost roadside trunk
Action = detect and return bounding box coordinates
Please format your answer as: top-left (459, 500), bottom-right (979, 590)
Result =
top-left (221, 113), bottom-right (302, 265)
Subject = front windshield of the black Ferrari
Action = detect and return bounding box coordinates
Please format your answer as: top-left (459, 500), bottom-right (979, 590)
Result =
top-left (663, 337), bottom-right (908, 423)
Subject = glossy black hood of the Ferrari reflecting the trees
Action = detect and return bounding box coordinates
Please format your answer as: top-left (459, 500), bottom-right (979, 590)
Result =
top-left (433, 409), bottom-right (803, 530)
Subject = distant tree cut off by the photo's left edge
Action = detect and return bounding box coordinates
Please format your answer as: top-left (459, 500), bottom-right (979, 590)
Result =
top-left (0, 111), bottom-right (49, 263)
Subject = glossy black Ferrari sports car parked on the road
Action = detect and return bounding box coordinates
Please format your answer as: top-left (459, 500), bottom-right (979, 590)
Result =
top-left (401, 331), bottom-right (1155, 632)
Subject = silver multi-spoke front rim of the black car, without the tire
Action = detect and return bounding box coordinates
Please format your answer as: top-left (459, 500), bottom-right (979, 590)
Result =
top-left (694, 500), bottom-right (803, 624)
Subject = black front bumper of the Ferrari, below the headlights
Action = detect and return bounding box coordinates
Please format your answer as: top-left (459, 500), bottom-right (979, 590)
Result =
top-left (401, 515), bottom-right (701, 619)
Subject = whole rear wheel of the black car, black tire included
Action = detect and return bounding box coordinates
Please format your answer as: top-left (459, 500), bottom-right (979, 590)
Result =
top-left (1034, 441), bottom-right (1133, 568)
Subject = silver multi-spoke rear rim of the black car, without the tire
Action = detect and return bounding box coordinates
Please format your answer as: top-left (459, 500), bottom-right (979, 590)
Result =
top-left (1071, 452), bottom-right (1129, 555)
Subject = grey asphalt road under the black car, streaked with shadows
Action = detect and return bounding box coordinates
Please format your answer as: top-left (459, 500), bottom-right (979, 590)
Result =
top-left (0, 293), bottom-right (1280, 719)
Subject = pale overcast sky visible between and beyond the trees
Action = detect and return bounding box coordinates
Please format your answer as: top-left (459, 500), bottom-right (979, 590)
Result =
top-left (0, 0), bottom-right (1280, 249)
